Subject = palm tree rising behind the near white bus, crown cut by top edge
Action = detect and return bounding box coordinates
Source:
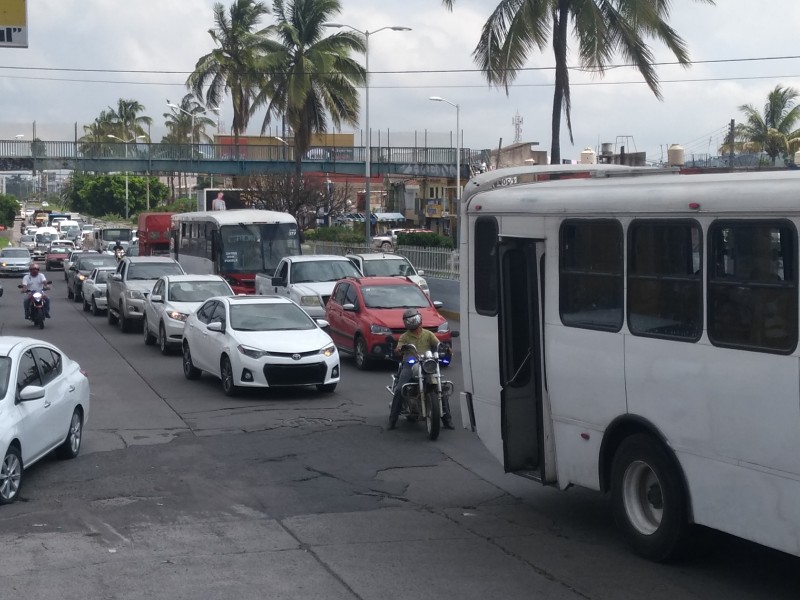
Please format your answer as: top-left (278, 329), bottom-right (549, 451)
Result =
top-left (442, 0), bottom-right (714, 164)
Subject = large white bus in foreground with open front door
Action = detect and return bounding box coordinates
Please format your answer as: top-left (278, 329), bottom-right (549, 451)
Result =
top-left (460, 165), bottom-right (800, 560)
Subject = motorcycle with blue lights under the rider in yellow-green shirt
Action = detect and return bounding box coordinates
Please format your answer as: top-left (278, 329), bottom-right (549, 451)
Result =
top-left (386, 336), bottom-right (455, 440)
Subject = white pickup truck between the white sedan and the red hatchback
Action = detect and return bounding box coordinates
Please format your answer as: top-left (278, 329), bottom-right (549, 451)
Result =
top-left (256, 254), bottom-right (362, 319)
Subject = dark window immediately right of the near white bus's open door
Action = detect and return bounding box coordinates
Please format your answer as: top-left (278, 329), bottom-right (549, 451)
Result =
top-left (559, 219), bottom-right (624, 331)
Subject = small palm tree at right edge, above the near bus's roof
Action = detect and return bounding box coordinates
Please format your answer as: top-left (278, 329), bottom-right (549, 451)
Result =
top-left (735, 85), bottom-right (800, 165)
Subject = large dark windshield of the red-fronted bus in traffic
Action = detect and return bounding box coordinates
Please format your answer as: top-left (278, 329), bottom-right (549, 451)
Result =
top-left (220, 223), bottom-right (300, 273)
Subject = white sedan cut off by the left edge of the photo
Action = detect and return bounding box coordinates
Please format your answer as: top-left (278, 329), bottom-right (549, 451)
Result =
top-left (0, 337), bottom-right (89, 504)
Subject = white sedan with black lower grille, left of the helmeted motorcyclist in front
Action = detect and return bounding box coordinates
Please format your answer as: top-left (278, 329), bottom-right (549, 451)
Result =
top-left (183, 296), bottom-right (339, 396)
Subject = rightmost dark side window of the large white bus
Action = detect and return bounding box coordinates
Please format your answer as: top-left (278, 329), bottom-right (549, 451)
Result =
top-left (708, 220), bottom-right (798, 354)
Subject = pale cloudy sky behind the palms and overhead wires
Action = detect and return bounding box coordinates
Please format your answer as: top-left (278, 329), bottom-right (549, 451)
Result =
top-left (0, 0), bottom-right (800, 161)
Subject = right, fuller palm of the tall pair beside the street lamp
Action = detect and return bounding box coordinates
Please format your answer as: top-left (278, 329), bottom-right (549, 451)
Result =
top-left (251, 0), bottom-right (366, 175)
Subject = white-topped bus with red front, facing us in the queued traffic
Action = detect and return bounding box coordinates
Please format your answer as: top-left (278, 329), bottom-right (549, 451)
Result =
top-left (170, 209), bottom-right (300, 294)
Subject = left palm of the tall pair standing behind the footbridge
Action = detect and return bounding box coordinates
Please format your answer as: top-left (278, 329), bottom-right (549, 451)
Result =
top-left (186, 0), bottom-right (269, 139)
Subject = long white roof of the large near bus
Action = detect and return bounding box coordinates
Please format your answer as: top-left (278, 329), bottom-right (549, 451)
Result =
top-left (464, 165), bottom-right (800, 216)
